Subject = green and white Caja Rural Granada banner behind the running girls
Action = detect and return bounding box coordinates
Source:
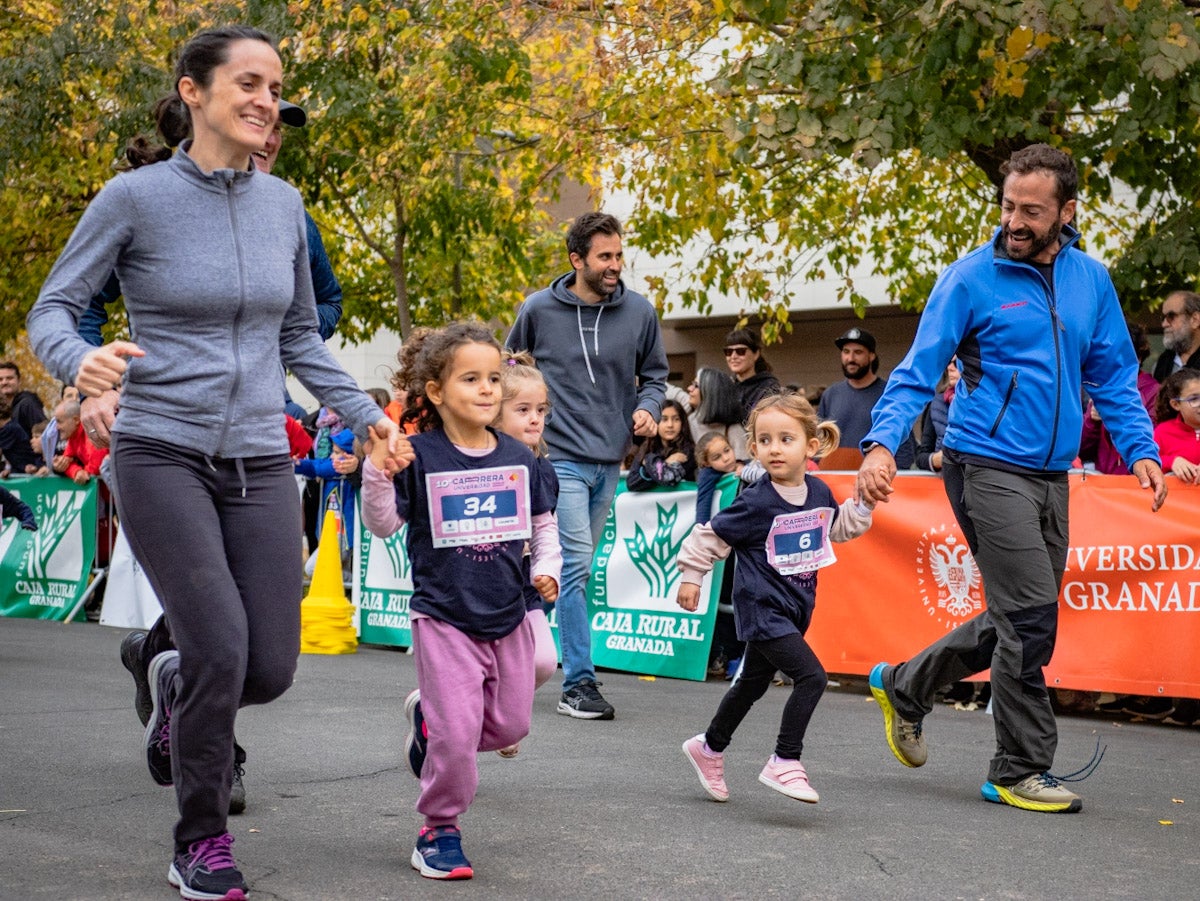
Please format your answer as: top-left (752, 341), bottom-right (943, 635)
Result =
top-left (353, 475), bottom-right (738, 680)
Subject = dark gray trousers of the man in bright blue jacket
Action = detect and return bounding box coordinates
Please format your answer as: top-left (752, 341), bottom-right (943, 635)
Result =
top-left (884, 465), bottom-right (1068, 785)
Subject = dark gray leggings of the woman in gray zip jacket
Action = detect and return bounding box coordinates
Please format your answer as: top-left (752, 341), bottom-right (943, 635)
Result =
top-left (113, 433), bottom-right (301, 851)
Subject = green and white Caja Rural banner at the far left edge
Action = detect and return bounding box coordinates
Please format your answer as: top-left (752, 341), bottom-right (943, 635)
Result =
top-left (0, 475), bottom-right (96, 620)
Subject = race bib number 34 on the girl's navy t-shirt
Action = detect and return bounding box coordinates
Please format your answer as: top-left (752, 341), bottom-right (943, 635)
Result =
top-left (425, 465), bottom-right (533, 547)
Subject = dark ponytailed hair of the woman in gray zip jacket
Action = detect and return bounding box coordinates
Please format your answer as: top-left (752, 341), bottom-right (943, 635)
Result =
top-left (125, 25), bottom-right (278, 169)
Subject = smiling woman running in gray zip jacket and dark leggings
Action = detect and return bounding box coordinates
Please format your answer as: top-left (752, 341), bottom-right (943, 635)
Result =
top-left (26, 26), bottom-right (403, 899)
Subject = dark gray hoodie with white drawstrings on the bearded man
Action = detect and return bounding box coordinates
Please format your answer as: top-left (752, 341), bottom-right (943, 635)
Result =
top-left (508, 272), bottom-right (667, 463)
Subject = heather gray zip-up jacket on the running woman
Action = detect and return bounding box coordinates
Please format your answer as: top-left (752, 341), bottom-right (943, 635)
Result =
top-left (25, 148), bottom-right (382, 457)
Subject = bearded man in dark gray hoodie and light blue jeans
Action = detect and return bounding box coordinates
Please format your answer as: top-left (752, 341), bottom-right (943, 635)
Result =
top-left (508, 212), bottom-right (667, 720)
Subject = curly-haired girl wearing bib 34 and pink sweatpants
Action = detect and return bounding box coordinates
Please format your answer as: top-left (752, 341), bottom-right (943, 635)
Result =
top-left (362, 323), bottom-right (562, 879)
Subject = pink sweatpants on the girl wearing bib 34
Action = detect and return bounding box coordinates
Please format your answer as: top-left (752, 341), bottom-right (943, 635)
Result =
top-left (413, 617), bottom-right (534, 827)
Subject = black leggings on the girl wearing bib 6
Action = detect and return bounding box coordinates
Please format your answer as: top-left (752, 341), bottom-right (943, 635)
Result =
top-left (704, 632), bottom-right (828, 761)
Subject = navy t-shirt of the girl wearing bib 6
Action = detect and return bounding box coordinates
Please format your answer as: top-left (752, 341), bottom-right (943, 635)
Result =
top-left (710, 475), bottom-right (838, 642)
